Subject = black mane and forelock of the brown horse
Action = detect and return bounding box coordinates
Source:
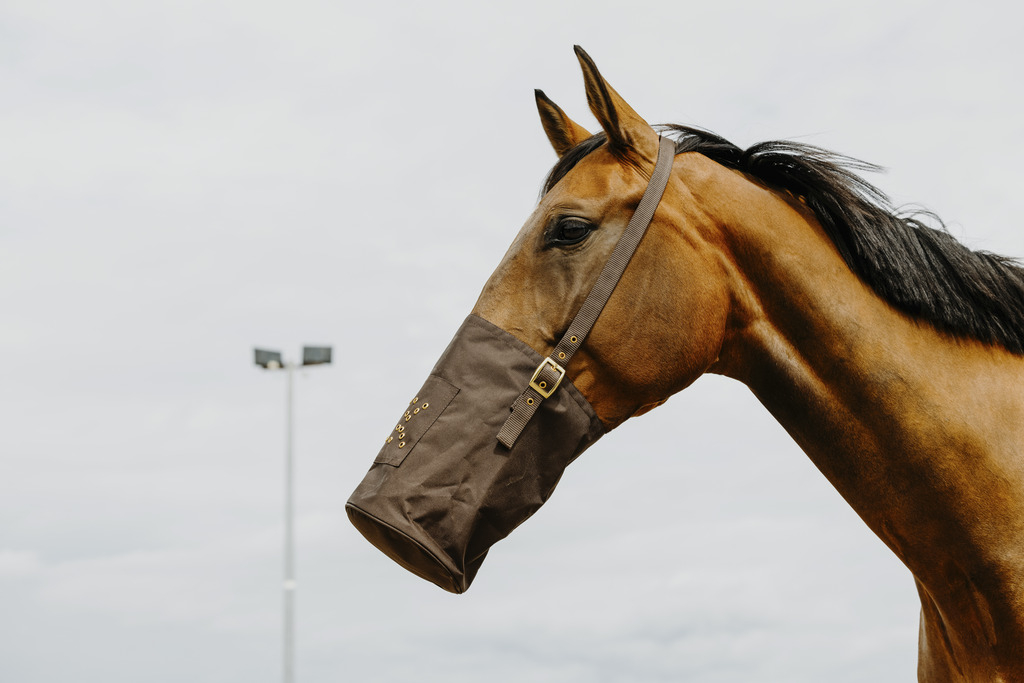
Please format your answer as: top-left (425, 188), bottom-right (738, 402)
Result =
top-left (544, 125), bottom-right (1024, 355)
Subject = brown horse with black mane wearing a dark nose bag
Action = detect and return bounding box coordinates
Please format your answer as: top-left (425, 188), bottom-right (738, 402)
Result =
top-left (348, 46), bottom-right (1024, 683)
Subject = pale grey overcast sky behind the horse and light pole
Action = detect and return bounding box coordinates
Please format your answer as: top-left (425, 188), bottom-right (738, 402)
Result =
top-left (6, 0), bottom-right (1024, 683)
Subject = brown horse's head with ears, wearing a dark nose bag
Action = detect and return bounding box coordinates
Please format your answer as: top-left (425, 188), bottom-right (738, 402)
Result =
top-left (347, 47), bottom-right (729, 593)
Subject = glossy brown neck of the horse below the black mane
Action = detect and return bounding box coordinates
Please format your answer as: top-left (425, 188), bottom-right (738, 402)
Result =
top-left (696, 162), bottom-right (1024, 655)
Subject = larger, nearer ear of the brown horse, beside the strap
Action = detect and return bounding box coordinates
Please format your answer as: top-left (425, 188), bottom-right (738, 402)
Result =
top-left (572, 45), bottom-right (658, 162)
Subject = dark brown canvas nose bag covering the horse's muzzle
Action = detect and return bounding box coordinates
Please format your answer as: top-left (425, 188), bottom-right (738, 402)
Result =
top-left (345, 315), bottom-right (604, 593)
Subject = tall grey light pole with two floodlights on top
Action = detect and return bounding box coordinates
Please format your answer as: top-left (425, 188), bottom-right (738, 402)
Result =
top-left (255, 346), bottom-right (331, 683)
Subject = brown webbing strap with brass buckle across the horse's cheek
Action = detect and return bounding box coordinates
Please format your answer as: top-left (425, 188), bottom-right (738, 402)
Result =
top-left (498, 137), bottom-right (676, 449)
